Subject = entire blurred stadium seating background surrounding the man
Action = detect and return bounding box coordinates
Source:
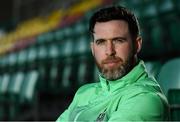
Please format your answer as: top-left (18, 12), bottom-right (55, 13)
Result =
top-left (0, 0), bottom-right (180, 121)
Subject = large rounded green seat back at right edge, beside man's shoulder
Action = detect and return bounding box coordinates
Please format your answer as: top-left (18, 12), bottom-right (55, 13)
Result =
top-left (157, 58), bottom-right (180, 95)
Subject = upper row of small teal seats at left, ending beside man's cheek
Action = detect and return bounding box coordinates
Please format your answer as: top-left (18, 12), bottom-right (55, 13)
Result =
top-left (0, 36), bottom-right (90, 72)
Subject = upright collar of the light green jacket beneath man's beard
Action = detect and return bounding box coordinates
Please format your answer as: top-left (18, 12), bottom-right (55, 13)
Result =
top-left (99, 60), bottom-right (147, 92)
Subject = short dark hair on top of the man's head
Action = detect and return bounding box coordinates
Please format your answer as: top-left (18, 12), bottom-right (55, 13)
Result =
top-left (89, 6), bottom-right (140, 39)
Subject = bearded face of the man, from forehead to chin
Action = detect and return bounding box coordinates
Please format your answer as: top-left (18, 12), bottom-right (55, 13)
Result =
top-left (91, 20), bottom-right (140, 80)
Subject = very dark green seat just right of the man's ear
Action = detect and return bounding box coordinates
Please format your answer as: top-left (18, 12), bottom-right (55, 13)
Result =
top-left (141, 18), bottom-right (167, 58)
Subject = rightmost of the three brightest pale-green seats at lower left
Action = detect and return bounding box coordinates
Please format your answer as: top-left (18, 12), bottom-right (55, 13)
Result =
top-left (20, 70), bottom-right (39, 120)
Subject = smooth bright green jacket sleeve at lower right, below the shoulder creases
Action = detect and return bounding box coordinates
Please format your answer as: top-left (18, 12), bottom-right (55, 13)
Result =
top-left (109, 93), bottom-right (168, 122)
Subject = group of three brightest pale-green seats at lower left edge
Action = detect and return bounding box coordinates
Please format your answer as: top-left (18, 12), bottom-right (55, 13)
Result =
top-left (0, 70), bottom-right (39, 120)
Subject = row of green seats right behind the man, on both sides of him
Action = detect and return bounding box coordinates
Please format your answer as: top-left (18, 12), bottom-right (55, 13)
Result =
top-left (0, 56), bottom-right (180, 120)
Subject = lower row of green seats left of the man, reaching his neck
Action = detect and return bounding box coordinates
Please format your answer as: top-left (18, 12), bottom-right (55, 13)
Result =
top-left (0, 56), bottom-right (98, 120)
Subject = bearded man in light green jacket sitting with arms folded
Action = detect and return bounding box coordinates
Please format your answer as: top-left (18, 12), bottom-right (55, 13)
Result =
top-left (57, 6), bottom-right (168, 121)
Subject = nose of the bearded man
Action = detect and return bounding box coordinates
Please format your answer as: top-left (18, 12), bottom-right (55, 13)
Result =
top-left (106, 41), bottom-right (116, 56)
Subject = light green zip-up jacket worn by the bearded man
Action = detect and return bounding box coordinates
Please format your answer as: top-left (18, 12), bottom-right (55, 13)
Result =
top-left (57, 61), bottom-right (168, 122)
